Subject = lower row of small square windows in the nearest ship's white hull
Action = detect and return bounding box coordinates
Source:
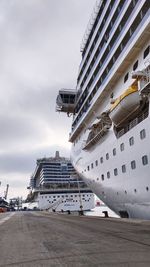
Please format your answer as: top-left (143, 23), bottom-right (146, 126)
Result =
top-left (97, 155), bottom-right (148, 181)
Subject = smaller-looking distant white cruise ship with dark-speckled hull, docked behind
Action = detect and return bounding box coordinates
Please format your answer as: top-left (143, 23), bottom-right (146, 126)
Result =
top-left (28, 151), bottom-right (95, 212)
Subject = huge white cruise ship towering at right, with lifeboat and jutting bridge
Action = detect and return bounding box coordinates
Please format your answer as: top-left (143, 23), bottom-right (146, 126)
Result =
top-left (56, 0), bottom-right (150, 219)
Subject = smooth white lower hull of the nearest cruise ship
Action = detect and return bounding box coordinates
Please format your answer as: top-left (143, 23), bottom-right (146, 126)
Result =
top-left (71, 117), bottom-right (150, 219)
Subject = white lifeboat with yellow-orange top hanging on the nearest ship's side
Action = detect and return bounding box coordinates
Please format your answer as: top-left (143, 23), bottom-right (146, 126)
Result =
top-left (109, 83), bottom-right (141, 127)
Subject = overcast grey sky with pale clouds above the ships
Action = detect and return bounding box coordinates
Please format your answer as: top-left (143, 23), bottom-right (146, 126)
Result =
top-left (0, 0), bottom-right (95, 198)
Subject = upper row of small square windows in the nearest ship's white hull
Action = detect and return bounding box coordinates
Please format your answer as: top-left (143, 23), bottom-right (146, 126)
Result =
top-left (87, 129), bottom-right (146, 171)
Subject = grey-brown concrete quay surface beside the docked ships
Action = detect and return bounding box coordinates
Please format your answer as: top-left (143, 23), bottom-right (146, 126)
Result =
top-left (0, 211), bottom-right (150, 267)
